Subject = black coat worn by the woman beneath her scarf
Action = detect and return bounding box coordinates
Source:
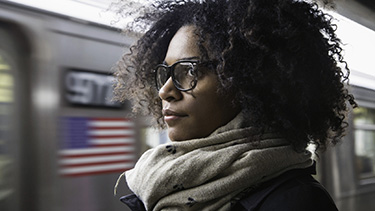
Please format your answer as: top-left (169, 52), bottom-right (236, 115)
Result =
top-left (121, 165), bottom-right (337, 211)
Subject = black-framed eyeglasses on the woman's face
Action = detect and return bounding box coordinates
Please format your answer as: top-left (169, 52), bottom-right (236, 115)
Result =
top-left (154, 60), bottom-right (199, 92)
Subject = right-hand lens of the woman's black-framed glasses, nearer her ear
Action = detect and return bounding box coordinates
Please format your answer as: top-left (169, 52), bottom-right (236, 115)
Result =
top-left (174, 62), bottom-right (197, 90)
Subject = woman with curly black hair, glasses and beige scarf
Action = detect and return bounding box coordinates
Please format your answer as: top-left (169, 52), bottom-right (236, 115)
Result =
top-left (116, 0), bottom-right (355, 210)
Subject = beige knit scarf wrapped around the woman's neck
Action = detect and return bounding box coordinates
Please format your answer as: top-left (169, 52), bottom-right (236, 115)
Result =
top-left (121, 115), bottom-right (313, 211)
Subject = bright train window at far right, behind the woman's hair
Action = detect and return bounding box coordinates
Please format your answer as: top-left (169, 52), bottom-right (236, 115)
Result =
top-left (354, 107), bottom-right (375, 179)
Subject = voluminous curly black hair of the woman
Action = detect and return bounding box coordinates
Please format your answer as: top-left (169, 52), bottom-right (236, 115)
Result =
top-left (115, 0), bottom-right (356, 150)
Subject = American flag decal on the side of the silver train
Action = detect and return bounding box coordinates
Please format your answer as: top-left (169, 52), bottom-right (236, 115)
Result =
top-left (59, 117), bottom-right (135, 176)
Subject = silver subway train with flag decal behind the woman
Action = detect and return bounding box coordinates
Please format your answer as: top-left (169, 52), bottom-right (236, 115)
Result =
top-left (0, 1), bottom-right (375, 211)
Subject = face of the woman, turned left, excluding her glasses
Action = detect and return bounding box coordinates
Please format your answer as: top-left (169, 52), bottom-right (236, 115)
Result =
top-left (159, 26), bottom-right (240, 141)
